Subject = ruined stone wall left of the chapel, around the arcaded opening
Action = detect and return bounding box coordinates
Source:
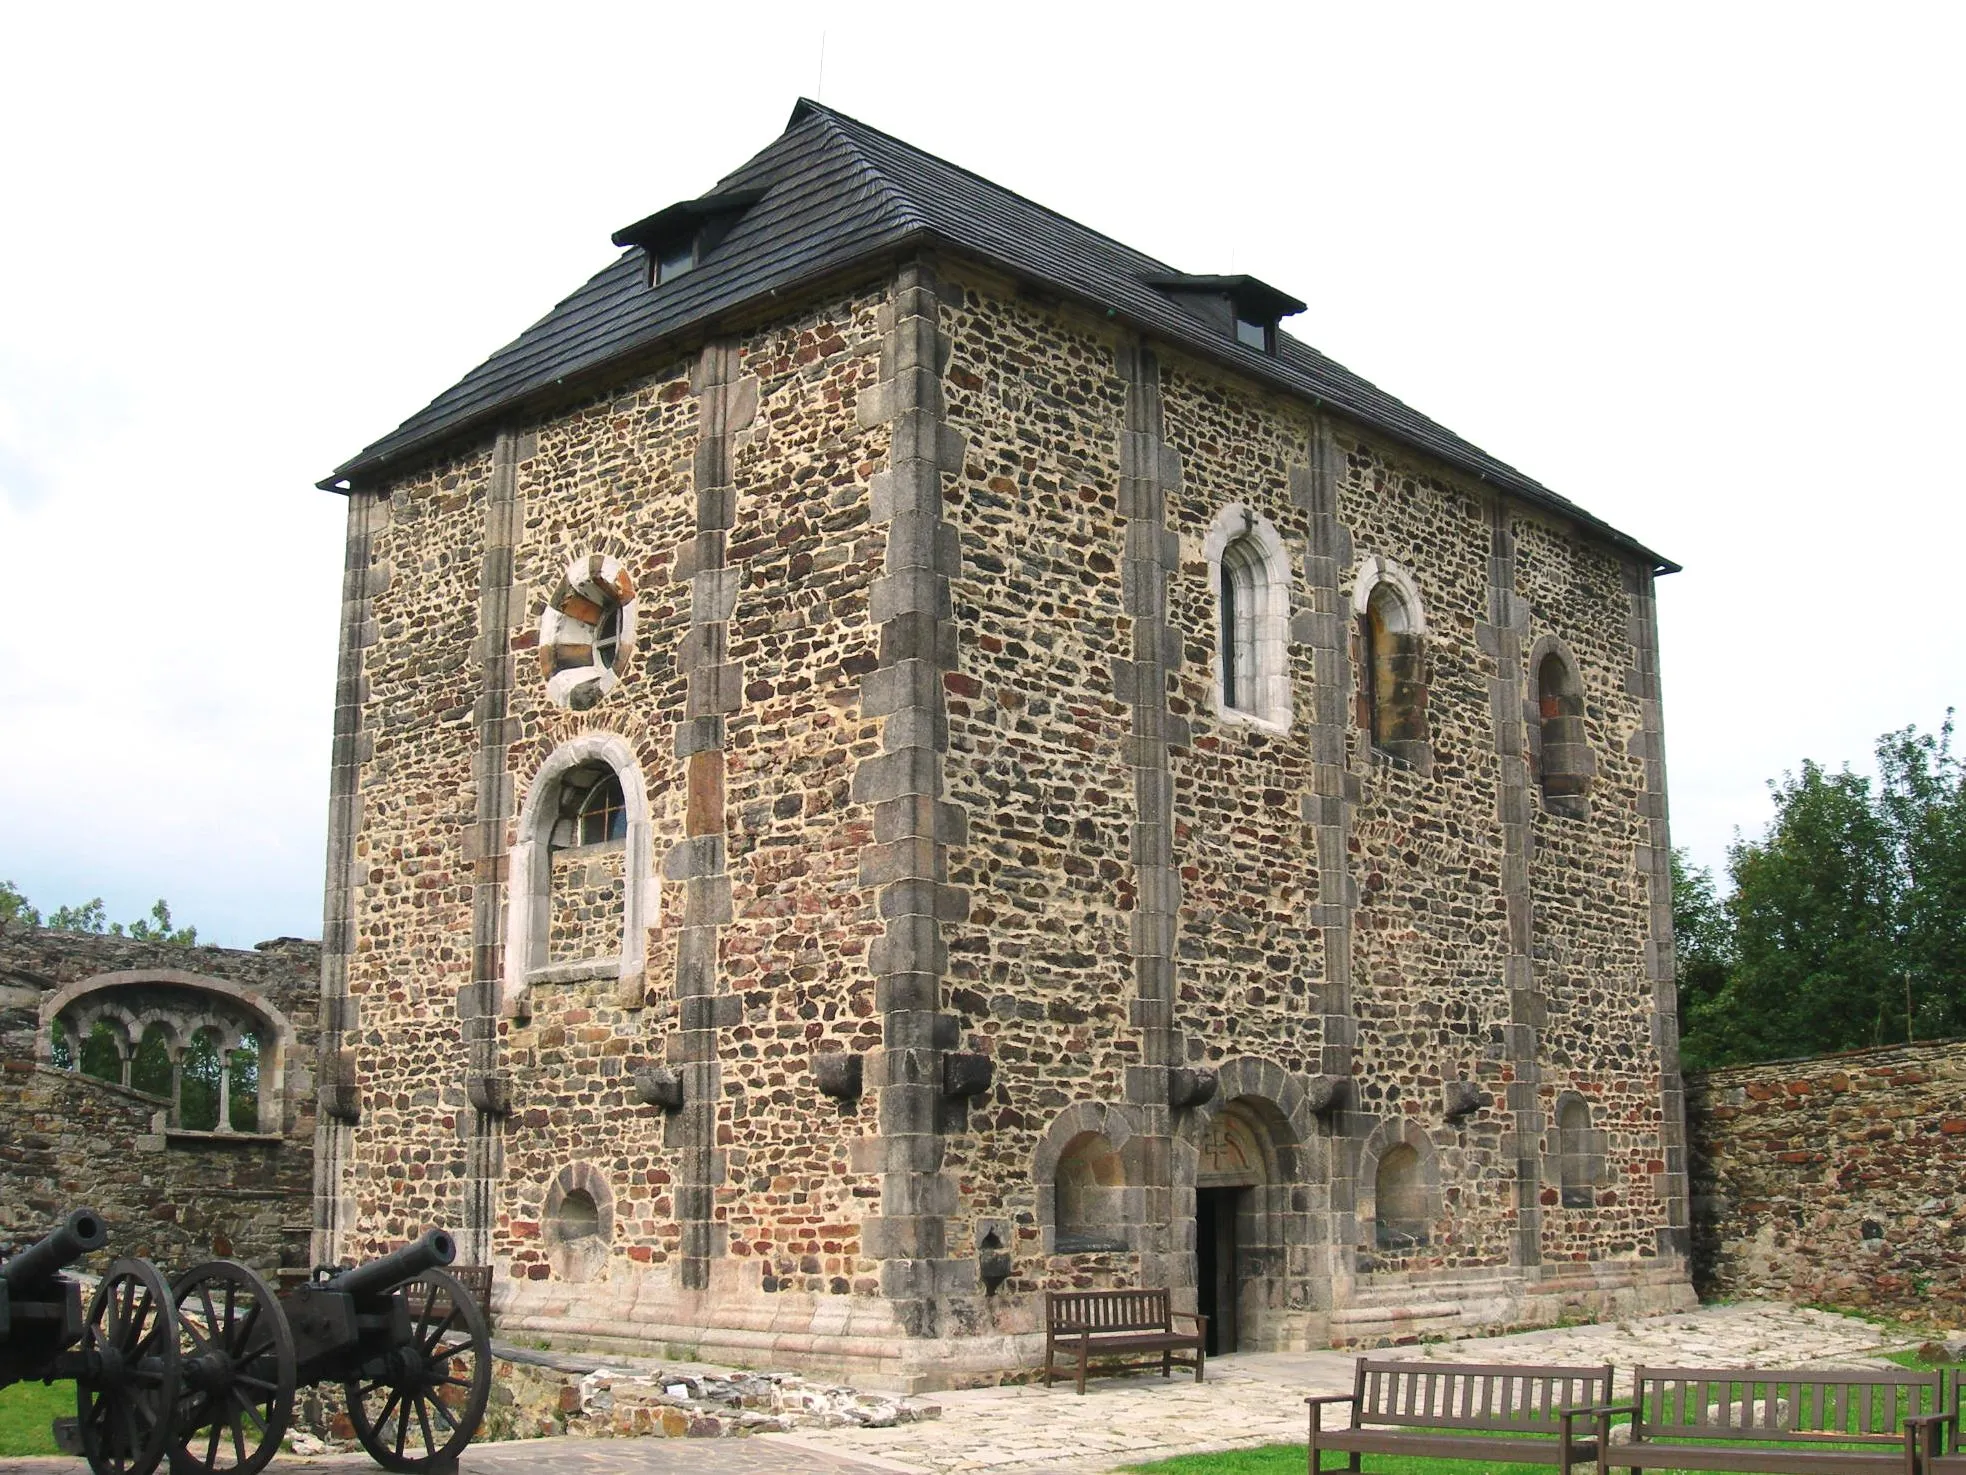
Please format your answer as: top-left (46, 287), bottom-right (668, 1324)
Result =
top-left (0, 928), bottom-right (318, 1272)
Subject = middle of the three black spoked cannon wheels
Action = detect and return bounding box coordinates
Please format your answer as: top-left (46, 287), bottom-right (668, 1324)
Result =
top-left (171, 1261), bottom-right (295, 1475)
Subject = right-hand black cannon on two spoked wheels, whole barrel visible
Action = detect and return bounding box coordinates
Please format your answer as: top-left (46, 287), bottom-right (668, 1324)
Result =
top-left (171, 1229), bottom-right (492, 1475)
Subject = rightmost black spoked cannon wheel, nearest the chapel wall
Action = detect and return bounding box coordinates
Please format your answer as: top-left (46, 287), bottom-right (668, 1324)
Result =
top-left (344, 1270), bottom-right (492, 1471)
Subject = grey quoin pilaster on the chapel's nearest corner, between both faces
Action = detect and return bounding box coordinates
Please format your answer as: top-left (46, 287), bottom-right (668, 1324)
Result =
top-left (853, 262), bottom-right (975, 1337)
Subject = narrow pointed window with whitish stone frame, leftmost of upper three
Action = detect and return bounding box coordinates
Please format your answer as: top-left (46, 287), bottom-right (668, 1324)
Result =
top-left (1203, 502), bottom-right (1292, 734)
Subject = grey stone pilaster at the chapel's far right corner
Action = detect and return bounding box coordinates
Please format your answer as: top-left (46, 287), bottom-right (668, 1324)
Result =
top-left (1624, 564), bottom-right (1693, 1270)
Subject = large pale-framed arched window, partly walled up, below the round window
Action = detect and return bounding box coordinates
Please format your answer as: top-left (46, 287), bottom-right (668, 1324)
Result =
top-left (503, 734), bottom-right (655, 1013)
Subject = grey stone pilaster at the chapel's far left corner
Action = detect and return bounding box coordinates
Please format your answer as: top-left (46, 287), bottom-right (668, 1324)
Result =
top-left (311, 492), bottom-right (389, 1265)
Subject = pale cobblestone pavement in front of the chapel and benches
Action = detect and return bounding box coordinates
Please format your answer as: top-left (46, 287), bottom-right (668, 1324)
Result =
top-left (0, 1302), bottom-right (1903, 1475)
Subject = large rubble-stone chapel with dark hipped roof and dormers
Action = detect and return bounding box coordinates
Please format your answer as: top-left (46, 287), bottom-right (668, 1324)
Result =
top-left (315, 102), bottom-right (1691, 1387)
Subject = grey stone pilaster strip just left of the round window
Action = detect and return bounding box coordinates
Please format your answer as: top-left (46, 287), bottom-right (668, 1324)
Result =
top-left (458, 431), bottom-right (535, 1265)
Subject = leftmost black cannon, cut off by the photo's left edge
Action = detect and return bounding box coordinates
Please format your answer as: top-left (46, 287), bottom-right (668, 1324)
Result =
top-left (0, 1210), bottom-right (181, 1475)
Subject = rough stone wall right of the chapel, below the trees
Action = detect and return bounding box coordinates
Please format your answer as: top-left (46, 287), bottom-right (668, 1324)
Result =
top-left (1687, 1040), bottom-right (1966, 1320)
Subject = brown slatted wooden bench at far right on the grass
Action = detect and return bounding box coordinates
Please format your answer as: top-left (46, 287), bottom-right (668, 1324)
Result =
top-left (1594, 1367), bottom-right (1942, 1475)
